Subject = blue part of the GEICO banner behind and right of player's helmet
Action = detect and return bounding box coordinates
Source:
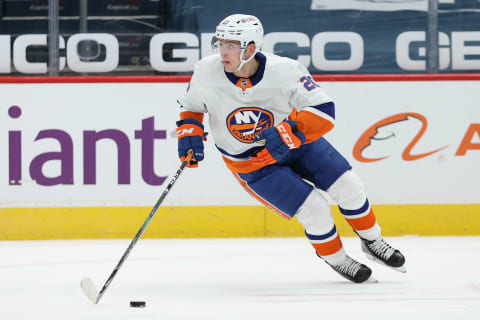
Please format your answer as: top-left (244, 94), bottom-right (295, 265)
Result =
top-left (177, 0), bottom-right (480, 73)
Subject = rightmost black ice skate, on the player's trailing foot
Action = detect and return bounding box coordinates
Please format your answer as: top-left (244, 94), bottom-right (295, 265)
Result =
top-left (360, 238), bottom-right (407, 273)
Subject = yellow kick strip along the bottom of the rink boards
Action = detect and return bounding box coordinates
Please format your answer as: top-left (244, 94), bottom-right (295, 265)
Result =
top-left (0, 205), bottom-right (480, 240)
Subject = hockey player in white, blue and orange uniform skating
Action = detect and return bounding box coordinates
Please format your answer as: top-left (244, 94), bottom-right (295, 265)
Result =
top-left (177, 14), bottom-right (405, 282)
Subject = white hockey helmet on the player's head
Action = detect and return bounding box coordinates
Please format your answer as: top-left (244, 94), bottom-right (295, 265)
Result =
top-left (212, 14), bottom-right (263, 71)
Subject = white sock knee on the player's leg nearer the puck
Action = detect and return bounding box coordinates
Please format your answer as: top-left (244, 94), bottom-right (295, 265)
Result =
top-left (296, 189), bottom-right (334, 235)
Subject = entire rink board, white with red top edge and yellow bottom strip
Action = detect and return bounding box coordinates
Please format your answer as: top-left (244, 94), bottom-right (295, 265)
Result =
top-left (0, 74), bottom-right (480, 240)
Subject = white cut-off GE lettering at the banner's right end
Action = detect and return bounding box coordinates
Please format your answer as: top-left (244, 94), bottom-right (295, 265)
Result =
top-left (395, 31), bottom-right (480, 70)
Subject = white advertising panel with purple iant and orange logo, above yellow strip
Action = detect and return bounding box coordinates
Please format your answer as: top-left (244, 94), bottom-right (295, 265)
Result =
top-left (0, 81), bottom-right (480, 207)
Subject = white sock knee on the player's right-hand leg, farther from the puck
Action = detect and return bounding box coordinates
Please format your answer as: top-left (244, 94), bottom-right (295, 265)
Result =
top-left (327, 170), bottom-right (367, 210)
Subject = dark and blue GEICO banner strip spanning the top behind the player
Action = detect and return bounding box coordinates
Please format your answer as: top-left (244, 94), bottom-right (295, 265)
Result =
top-left (0, 0), bottom-right (480, 74)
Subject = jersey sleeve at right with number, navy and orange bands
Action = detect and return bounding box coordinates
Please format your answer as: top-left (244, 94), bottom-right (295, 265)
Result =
top-left (290, 63), bottom-right (335, 143)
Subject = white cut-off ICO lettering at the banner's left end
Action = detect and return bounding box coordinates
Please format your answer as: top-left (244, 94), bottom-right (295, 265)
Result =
top-left (0, 33), bottom-right (119, 74)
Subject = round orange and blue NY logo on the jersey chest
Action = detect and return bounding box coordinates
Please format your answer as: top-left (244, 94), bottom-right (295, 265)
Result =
top-left (227, 107), bottom-right (273, 143)
